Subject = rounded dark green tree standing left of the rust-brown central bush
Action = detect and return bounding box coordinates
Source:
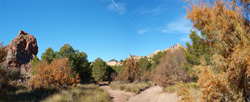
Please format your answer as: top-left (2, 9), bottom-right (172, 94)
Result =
top-left (91, 58), bottom-right (109, 82)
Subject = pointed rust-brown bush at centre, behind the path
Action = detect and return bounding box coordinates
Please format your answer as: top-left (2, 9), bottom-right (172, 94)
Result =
top-left (116, 56), bottom-right (141, 83)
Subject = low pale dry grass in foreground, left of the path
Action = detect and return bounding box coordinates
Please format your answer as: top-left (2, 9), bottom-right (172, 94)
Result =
top-left (42, 84), bottom-right (110, 102)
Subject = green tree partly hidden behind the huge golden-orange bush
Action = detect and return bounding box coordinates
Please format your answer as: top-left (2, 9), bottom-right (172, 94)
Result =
top-left (184, 31), bottom-right (212, 81)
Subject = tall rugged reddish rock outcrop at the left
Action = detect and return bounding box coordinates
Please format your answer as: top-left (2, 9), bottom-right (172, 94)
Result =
top-left (3, 30), bottom-right (38, 76)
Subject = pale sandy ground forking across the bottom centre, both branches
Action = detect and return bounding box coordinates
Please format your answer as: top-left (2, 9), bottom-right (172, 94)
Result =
top-left (101, 86), bottom-right (178, 102)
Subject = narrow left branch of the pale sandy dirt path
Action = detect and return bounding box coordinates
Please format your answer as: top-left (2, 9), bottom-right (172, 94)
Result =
top-left (100, 86), bottom-right (136, 102)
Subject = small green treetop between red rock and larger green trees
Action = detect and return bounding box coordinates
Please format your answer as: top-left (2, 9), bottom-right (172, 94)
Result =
top-left (41, 47), bottom-right (55, 63)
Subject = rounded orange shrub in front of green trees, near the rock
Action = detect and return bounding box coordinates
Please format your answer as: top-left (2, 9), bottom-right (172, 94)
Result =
top-left (29, 58), bottom-right (80, 89)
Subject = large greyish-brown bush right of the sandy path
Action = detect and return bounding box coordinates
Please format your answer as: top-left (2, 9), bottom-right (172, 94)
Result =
top-left (152, 48), bottom-right (189, 86)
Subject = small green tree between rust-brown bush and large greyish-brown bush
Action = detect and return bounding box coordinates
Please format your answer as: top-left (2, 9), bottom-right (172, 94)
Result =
top-left (138, 57), bottom-right (151, 74)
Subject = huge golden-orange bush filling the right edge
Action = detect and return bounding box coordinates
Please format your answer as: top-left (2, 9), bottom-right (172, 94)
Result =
top-left (187, 0), bottom-right (250, 102)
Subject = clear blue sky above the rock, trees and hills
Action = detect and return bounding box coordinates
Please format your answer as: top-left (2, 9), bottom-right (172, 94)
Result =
top-left (0, 0), bottom-right (192, 61)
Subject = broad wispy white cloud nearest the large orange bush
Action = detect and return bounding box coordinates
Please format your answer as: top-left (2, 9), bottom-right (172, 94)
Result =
top-left (161, 18), bottom-right (192, 34)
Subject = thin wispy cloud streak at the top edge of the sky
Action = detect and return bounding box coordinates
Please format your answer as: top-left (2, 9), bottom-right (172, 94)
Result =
top-left (108, 0), bottom-right (127, 15)
